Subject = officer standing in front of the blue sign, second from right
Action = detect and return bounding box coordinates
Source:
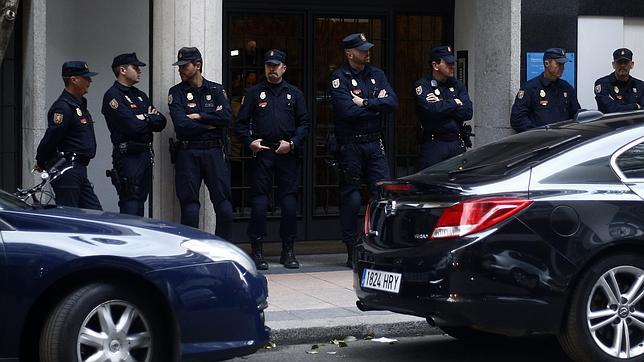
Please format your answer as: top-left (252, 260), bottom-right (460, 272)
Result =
top-left (510, 48), bottom-right (580, 132)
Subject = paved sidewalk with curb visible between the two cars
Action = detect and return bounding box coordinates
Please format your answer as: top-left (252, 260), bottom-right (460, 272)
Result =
top-left (264, 254), bottom-right (442, 345)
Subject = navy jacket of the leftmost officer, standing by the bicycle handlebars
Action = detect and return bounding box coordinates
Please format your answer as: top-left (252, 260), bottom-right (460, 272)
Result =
top-left (36, 90), bottom-right (96, 167)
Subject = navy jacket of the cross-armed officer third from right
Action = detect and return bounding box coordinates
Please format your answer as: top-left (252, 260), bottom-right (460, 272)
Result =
top-left (414, 75), bottom-right (474, 133)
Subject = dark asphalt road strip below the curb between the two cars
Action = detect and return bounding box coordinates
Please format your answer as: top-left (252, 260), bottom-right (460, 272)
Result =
top-left (234, 335), bottom-right (570, 362)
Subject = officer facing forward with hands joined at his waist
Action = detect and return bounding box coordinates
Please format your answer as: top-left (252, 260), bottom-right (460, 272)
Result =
top-left (235, 49), bottom-right (311, 270)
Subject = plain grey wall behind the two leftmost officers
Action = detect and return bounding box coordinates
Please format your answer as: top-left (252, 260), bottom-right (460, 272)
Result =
top-left (46, 0), bottom-right (150, 211)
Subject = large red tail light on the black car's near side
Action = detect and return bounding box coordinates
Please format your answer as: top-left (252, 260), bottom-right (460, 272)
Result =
top-left (430, 197), bottom-right (532, 239)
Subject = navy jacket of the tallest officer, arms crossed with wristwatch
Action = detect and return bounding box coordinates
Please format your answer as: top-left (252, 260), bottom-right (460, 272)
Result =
top-left (330, 63), bottom-right (398, 136)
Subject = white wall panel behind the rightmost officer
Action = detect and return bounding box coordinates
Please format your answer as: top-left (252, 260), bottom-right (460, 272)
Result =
top-left (577, 16), bottom-right (644, 109)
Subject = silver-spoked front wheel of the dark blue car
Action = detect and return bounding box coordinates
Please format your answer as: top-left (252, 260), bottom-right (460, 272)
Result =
top-left (39, 283), bottom-right (170, 362)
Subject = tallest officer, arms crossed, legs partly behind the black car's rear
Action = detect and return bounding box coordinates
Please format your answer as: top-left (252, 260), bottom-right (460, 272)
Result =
top-left (330, 33), bottom-right (398, 267)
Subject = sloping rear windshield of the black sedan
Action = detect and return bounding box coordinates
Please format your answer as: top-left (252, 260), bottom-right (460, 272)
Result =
top-left (421, 128), bottom-right (596, 175)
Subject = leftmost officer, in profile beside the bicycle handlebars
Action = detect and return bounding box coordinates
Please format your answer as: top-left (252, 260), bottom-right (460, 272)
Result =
top-left (34, 61), bottom-right (102, 210)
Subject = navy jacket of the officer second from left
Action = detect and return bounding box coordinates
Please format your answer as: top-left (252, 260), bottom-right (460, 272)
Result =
top-left (101, 82), bottom-right (166, 144)
